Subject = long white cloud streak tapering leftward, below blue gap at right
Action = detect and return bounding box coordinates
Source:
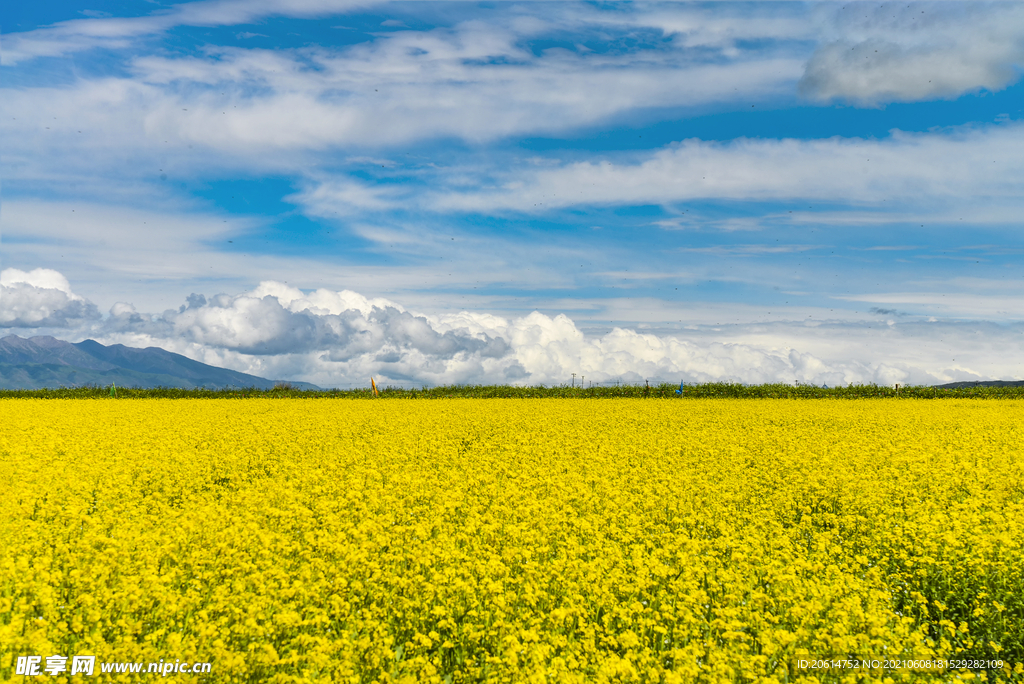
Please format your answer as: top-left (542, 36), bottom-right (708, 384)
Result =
top-left (431, 124), bottom-right (1024, 213)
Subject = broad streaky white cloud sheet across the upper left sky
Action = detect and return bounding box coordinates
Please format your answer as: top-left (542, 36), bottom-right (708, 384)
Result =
top-left (0, 2), bottom-right (803, 179)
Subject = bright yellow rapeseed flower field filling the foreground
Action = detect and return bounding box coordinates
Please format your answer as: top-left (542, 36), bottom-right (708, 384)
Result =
top-left (0, 399), bottom-right (1024, 684)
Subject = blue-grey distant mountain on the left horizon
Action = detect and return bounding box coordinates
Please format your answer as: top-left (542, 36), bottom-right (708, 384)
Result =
top-left (0, 335), bottom-right (319, 389)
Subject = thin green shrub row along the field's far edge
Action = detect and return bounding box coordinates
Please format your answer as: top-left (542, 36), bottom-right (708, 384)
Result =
top-left (0, 383), bottom-right (1024, 399)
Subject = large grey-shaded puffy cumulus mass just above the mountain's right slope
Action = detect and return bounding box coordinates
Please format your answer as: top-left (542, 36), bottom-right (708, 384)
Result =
top-left (95, 282), bottom-right (519, 385)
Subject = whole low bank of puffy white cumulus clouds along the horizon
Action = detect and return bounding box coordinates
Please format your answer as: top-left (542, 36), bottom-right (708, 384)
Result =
top-left (0, 269), bottom-right (1019, 387)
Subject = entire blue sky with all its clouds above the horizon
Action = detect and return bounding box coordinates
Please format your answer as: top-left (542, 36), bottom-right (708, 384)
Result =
top-left (0, 0), bottom-right (1024, 386)
